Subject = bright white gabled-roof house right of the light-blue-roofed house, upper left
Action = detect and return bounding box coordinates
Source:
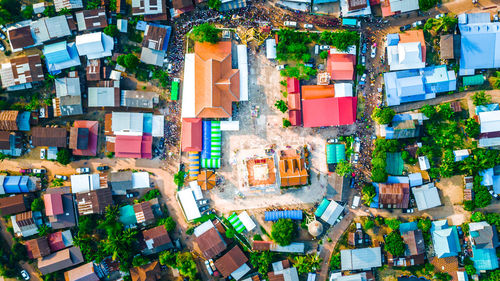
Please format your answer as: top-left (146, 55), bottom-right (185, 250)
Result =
top-left (75, 32), bottom-right (114, 60)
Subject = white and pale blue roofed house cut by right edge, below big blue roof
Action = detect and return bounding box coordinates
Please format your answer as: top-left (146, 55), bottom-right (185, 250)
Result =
top-left (478, 110), bottom-right (500, 147)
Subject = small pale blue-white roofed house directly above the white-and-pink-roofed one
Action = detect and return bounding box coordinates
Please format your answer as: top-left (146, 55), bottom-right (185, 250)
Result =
top-left (88, 80), bottom-right (120, 107)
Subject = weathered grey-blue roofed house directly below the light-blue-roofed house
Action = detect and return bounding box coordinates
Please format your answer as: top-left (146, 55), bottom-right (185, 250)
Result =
top-left (52, 77), bottom-right (83, 116)
